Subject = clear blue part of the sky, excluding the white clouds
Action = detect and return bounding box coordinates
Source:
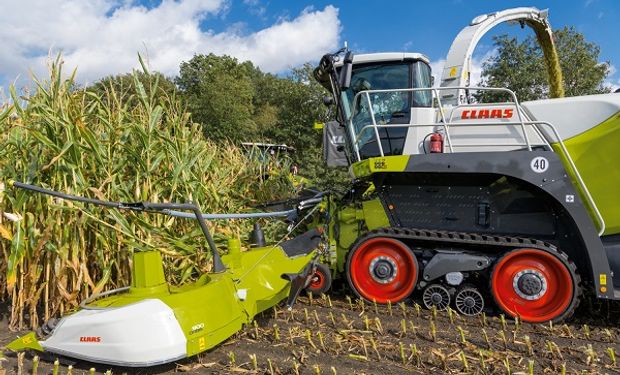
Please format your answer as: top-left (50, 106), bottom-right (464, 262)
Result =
top-left (209, 0), bottom-right (620, 64)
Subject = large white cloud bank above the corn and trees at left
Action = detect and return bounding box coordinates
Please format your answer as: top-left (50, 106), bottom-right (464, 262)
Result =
top-left (0, 0), bottom-right (341, 82)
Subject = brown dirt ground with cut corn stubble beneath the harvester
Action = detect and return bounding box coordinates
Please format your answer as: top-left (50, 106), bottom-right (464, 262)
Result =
top-left (0, 288), bottom-right (620, 375)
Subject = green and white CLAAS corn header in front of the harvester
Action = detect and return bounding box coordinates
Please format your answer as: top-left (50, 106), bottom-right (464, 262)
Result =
top-left (7, 182), bottom-right (322, 367)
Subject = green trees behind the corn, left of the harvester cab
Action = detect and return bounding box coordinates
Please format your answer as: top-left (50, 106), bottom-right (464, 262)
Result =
top-left (175, 54), bottom-right (346, 191)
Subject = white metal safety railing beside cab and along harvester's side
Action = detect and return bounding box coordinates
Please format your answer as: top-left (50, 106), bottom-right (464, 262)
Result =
top-left (347, 87), bottom-right (605, 235)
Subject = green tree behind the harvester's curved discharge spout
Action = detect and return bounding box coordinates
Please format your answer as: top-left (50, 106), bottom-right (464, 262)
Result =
top-left (479, 27), bottom-right (610, 101)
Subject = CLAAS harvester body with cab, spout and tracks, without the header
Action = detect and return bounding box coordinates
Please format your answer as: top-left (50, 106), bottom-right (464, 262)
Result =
top-left (314, 8), bottom-right (620, 322)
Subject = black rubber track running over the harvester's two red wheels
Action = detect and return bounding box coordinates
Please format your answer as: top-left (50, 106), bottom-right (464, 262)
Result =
top-left (347, 227), bottom-right (582, 322)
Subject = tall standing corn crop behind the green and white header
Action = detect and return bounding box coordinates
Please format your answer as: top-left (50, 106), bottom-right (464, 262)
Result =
top-left (0, 56), bottom-right (291, 329)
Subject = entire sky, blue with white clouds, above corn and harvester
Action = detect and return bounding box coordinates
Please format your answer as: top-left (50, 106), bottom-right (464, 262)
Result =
top-left (0, 0), bottom-right (620, 94)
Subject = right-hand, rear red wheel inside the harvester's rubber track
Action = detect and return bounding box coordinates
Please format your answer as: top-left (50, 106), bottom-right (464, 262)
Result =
top-left (491, 249), bottom-right (574, 323)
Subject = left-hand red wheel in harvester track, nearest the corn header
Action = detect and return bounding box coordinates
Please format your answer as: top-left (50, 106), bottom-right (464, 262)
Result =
top-left (349, 238), bottom-right (418, 303)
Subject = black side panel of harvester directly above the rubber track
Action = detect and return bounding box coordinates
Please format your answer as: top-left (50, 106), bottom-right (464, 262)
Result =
top-left (381, 181), bottom-right (556, 235)
